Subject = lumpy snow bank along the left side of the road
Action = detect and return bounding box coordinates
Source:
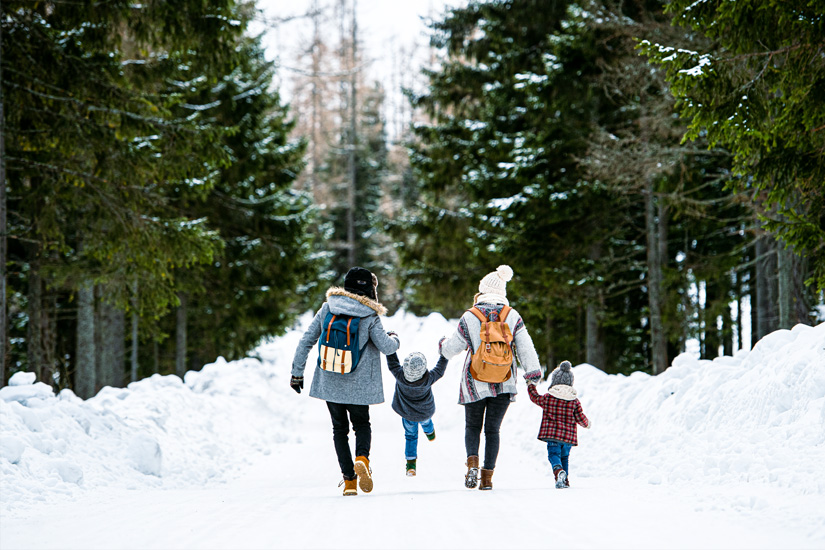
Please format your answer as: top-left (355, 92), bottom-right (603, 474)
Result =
top-left (0, 350), bottom-right (297, 512)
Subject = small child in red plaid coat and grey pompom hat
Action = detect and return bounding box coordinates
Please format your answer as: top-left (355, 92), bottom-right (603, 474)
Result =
top-left (527, 361), bottom-right (590, 489)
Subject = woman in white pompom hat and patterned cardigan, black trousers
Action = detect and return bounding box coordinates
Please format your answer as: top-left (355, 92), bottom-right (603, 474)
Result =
top-left (441, 265), bottom-right (541, 490)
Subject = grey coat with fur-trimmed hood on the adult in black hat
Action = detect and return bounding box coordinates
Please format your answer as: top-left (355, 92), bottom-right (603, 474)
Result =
top-left (292, 287), bottom-right (399, 405)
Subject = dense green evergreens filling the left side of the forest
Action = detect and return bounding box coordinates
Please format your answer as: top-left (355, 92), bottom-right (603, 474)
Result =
top-left (2, 0), bottom-right (317, 390)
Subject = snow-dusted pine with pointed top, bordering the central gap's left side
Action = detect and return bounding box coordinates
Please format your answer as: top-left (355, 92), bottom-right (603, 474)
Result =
top-left (169, 33), bottom-right (319, 368)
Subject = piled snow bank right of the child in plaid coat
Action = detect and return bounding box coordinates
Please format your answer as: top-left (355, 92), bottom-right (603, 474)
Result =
top-left (526, 324), bottom-right (825, 494)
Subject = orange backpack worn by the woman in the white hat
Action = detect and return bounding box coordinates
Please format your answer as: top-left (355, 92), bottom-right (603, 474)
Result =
top-left (467, 306), bottom-right (513, 384)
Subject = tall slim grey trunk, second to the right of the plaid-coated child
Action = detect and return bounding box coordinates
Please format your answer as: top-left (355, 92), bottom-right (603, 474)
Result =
top-left (644, 182), bottom-right (667, 374)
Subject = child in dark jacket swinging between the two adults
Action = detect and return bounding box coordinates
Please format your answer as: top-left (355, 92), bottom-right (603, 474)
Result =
top-left (387, 351), bottom-right (447, 476)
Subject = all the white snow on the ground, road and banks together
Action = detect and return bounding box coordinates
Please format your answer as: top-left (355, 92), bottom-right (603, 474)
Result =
top-left (0, 312), bottom-right (825, 549)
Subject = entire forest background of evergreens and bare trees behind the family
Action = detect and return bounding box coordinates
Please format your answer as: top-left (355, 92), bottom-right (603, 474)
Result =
top-left (0, 0), bottom-right (825, 398)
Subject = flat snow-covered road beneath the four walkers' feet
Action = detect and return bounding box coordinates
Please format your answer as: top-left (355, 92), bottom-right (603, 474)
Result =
top-left (0, 398), bottom-right (825, 550)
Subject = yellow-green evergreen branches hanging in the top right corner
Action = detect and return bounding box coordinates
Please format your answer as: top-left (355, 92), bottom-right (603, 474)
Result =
top-left (642, 0), bottom-right (825, 290)
